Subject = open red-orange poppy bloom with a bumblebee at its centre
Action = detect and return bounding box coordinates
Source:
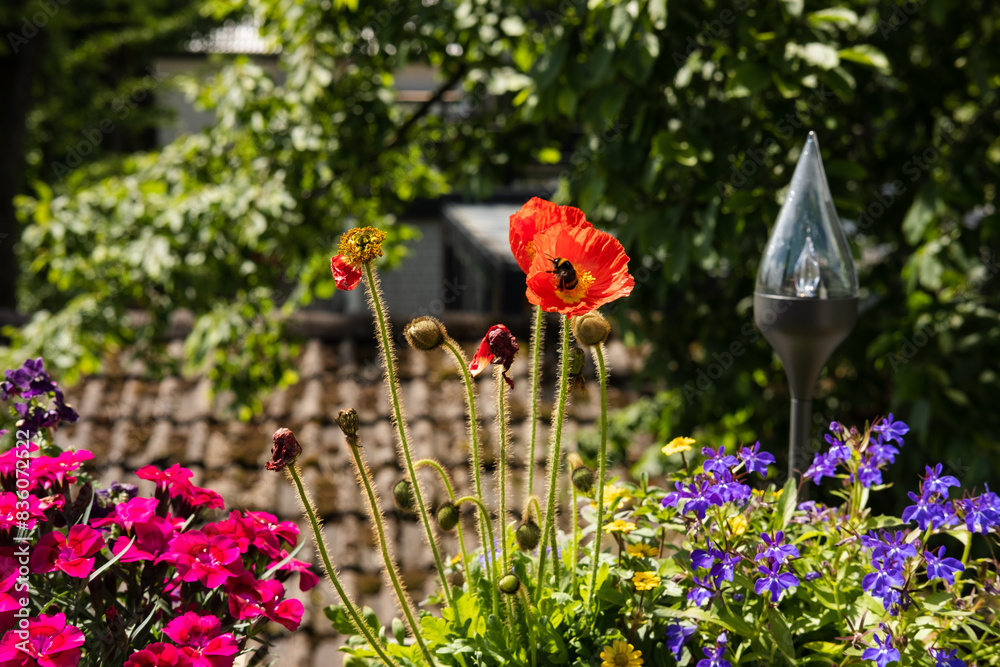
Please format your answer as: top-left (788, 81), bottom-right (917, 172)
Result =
top-left (526, 225), bottom-right (635, 316)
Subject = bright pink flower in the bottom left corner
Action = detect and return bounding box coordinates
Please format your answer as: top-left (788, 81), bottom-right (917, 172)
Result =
top-left (0, 613), bottom-right (84, 667)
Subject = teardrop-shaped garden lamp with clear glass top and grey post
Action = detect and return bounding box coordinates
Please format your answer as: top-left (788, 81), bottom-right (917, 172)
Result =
top-left (753, 132), bottom-right (858, 476)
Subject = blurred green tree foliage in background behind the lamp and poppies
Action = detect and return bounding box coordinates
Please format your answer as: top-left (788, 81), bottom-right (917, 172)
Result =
top-left (0, 0), bottom-right (1000, 504)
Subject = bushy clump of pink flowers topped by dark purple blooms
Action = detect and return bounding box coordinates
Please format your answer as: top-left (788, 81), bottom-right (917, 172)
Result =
top-left (0, 358), bottom-right (319, 667)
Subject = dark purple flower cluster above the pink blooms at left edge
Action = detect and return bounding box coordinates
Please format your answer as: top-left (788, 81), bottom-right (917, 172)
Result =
top-left (0, 357), bottom-right (80, 436)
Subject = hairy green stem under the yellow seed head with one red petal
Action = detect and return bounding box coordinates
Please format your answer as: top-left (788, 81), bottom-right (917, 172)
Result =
top-left (364, 262), bottom-right (455, 607)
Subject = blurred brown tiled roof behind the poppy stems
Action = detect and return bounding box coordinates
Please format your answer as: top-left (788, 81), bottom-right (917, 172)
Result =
top-left (56, 320), bottom-right (641, 667)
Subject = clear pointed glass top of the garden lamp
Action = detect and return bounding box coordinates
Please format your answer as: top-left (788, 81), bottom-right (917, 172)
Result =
top-left (756, 132), bottom-right (858, 299)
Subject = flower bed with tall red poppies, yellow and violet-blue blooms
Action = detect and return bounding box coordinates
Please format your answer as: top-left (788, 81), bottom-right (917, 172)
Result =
top-left (268, 199), bottom-right (1000, 667)
